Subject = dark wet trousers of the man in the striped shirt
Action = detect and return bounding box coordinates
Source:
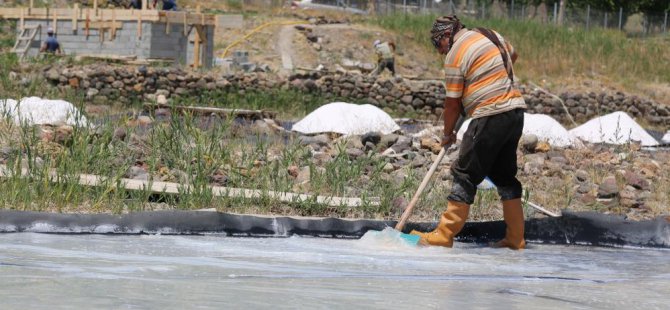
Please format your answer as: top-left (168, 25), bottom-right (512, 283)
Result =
top-left (448, 109), bottom-right (523, 204)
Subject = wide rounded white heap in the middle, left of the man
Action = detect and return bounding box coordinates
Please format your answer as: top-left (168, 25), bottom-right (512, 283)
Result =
top-left (292, 102), bottom-right (400, 135)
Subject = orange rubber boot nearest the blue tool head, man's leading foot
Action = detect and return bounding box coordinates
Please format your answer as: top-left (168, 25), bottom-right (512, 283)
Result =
top-left (410, 201), bottom-right (470, 248)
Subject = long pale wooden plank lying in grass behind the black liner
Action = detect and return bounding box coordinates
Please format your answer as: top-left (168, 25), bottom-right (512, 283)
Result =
top-left (0, 165), bottom-right (379, 207)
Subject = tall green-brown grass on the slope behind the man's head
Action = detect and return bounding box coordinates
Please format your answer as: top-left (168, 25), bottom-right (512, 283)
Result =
top-left (371, 15), bottom-right (670, 84)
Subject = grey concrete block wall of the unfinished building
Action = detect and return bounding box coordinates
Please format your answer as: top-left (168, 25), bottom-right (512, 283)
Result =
top-left (17, 19), bottom-right (214, 67)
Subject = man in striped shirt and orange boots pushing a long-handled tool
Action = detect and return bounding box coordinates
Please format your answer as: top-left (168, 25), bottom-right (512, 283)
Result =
top-left (412, 15), bottom-right (526, 249)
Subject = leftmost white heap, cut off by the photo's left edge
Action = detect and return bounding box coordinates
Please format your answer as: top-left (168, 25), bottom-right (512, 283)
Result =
top-left (0, 97), bottom-right (88, 126)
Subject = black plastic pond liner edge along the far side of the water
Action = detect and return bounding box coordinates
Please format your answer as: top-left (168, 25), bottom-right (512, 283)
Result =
top-left (0, 210), bottom-right (670, 248)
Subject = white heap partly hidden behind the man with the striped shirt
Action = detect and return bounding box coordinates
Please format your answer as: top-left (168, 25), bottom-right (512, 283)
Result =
top-left (456, 113), bottom-right (582, 147)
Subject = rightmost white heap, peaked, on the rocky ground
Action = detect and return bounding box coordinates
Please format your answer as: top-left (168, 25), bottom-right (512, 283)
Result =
top-left (570, 111), bottom-right (658, 146)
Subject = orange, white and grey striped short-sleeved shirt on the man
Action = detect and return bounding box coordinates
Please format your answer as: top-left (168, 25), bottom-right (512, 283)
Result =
top-left (444, 29), bottom-right (526, 118)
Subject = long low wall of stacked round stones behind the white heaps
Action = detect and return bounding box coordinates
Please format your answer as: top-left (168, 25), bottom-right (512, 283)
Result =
top-left (45, 65), bottom-right (670, 126)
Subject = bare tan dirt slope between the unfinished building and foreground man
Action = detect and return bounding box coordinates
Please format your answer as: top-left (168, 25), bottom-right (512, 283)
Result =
top-left (215, 12), bottom-right (441, 78)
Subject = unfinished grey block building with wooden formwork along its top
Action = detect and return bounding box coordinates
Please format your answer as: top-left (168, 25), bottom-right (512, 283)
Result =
top-left (0, 0), bottom-right (242, 68)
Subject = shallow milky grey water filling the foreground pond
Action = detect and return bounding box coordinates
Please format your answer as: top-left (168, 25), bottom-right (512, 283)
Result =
top-left (0, 233), bottom-right (670, 309)
